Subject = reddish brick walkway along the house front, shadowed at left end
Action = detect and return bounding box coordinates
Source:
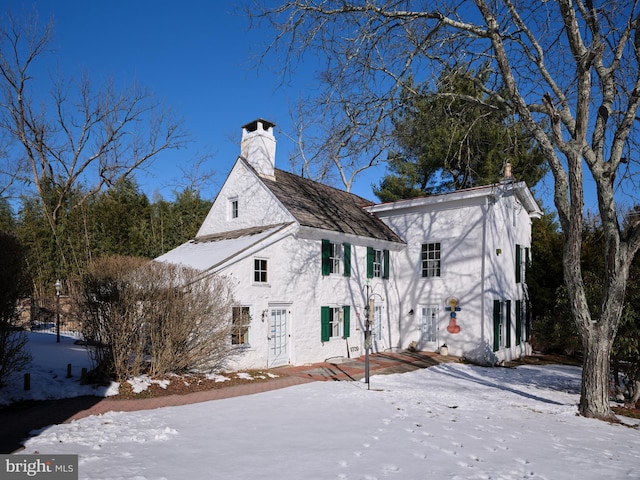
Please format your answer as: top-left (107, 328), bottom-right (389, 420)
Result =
top-left (0, 352), bottom-right (458, 453)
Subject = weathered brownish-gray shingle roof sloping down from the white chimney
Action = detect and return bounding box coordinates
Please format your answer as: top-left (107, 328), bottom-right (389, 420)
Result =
top-left (261, 168), bottom-right (404, 243)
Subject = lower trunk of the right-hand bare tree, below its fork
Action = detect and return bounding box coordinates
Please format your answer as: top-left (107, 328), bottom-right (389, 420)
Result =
top-left (580, 330), bottom-right (615, 420)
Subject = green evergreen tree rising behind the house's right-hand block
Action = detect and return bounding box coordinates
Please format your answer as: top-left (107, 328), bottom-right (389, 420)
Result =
top-left (374, 72), bottom-right (545, 201)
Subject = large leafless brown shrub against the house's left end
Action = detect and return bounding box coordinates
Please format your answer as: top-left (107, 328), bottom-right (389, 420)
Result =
top-left (79, 257), bottom-right (233, 380)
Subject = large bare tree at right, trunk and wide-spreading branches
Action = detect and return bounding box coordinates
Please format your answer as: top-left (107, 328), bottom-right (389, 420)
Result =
top-left (251, 0), bottom-right (640, 419)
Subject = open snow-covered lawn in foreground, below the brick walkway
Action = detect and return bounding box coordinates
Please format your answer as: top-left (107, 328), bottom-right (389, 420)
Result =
top-left (0, 334), bottom-right (640, 480)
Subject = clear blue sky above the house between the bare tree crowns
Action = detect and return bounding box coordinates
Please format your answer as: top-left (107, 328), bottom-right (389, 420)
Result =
top-left (2, 0), bottom-right (608, 214)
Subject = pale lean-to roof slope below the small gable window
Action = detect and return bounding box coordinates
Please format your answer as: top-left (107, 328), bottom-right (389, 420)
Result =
top-left (156, 223), bottom-right (290, 271)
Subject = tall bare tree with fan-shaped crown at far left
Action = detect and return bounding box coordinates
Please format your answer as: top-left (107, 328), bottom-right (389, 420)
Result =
top-left (0, 8), bottom-right (187, 274)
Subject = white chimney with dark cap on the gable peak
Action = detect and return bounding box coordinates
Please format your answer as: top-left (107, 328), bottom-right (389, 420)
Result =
top-left (240, 118), bottom-right (276, 180)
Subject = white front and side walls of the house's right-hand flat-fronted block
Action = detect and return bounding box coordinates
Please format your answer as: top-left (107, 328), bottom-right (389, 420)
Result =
top-left (377, 185), bottom-right (531, 362)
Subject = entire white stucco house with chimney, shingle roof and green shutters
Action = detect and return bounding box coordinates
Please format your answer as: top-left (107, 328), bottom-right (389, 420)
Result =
top-left (157, 119), bottom-right (542, 368)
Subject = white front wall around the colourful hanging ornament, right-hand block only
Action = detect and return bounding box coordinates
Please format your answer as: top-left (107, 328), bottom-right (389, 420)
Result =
top-left (383, 194), bottom-right (484, 355)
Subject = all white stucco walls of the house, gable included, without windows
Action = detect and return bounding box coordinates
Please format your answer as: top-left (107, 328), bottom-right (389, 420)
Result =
top-left (189, 160), bottom-right (531, 368)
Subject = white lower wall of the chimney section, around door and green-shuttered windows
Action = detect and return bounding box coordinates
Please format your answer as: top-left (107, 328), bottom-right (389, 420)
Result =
top-left (221, 232), bottom-right (398, 368)
